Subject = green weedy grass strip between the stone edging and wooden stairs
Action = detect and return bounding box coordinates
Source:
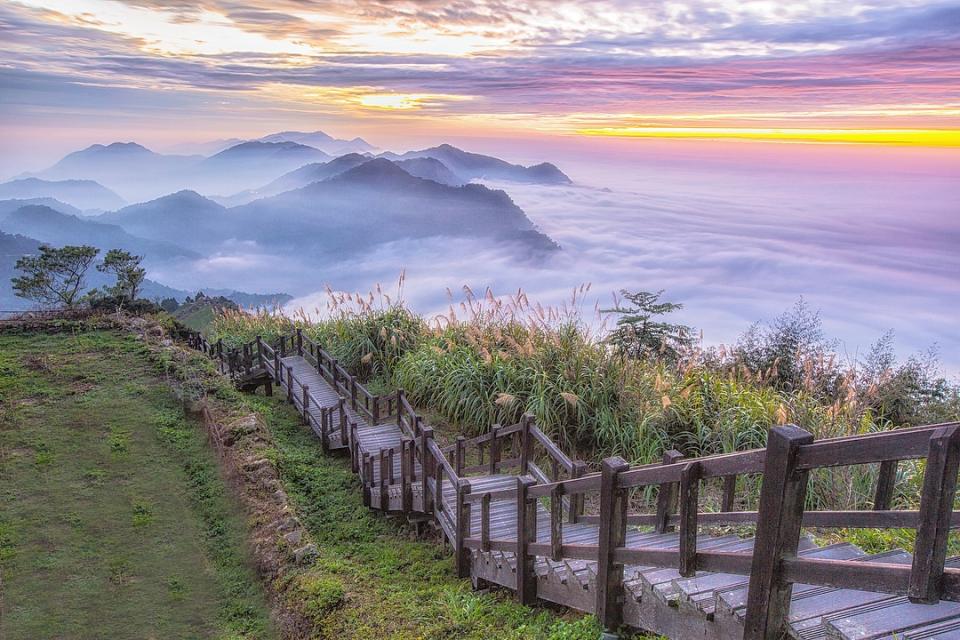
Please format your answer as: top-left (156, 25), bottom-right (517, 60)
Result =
top-left (234, 396), bottom-right (632, 640)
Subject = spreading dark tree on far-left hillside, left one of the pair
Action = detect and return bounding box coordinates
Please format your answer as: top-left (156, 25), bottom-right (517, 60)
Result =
top-left (11, 245), bottom-right (100, 307)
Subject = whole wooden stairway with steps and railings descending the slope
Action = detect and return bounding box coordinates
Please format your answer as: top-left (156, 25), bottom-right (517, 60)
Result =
top-left (191, 334), bottom-right (960, 640)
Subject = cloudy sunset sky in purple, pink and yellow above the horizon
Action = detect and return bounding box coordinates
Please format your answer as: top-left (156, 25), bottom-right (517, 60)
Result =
top-left (0, 0), bottom-right (960, 170)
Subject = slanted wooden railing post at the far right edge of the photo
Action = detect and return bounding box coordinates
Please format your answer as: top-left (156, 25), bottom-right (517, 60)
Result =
top-left (907, 425), bottom-right (960, 604)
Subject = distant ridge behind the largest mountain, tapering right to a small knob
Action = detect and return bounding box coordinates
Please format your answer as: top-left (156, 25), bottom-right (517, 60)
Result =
top-left (382, 144), bottom-right (571, 184)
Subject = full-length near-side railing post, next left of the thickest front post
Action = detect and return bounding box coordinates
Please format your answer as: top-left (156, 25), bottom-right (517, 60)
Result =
top-left (596, 457), bottom-right (630, 632)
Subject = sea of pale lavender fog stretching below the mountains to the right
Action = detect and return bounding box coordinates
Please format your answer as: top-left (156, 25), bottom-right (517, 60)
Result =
top-left (151, 141), bottom-right (960, 372)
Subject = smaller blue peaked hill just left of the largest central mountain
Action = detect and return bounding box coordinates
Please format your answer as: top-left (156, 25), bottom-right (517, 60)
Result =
top-left (96, 190), bottom-right (232, 253)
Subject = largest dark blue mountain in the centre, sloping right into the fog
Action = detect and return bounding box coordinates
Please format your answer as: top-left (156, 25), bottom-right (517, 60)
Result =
top-left (230, 158), bottom-right (557, 255)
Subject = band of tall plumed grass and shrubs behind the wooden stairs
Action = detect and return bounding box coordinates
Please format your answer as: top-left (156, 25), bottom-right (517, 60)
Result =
top-left (212, 284), bottom-right (960, 507)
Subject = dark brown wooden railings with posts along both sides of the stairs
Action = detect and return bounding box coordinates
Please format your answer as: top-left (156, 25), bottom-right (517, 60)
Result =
top-left (189, 332), bottom-right (960, 640)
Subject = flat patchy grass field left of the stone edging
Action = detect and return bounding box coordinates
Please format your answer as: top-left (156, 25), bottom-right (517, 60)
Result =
top-left (0, 331), bottom-right (275, 640)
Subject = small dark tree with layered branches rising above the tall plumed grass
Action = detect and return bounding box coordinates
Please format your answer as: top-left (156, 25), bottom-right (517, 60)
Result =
top-left (601, 289), bottom-right (692, 362)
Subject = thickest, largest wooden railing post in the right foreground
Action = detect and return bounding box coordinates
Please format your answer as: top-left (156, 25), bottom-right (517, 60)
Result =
top-left (743, 425), bottom-right (813, 640)
